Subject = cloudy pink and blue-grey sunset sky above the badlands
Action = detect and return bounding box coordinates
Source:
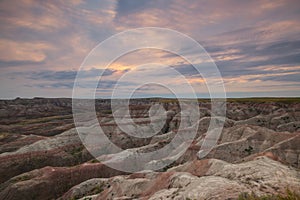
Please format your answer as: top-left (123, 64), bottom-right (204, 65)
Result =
top-left (0, 0), bottom-right (300, 99)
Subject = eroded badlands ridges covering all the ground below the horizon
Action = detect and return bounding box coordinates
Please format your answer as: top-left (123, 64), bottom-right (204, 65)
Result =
top-left (0, 98), bottom-right (300, 200)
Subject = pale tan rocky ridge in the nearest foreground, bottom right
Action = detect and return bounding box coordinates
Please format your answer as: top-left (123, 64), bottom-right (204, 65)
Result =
top-left (61, 157), bottom-right (300, 200)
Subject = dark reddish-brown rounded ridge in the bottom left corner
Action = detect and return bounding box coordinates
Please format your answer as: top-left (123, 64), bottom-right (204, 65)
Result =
top-left (0, 163), bottom-right (124, 200)
